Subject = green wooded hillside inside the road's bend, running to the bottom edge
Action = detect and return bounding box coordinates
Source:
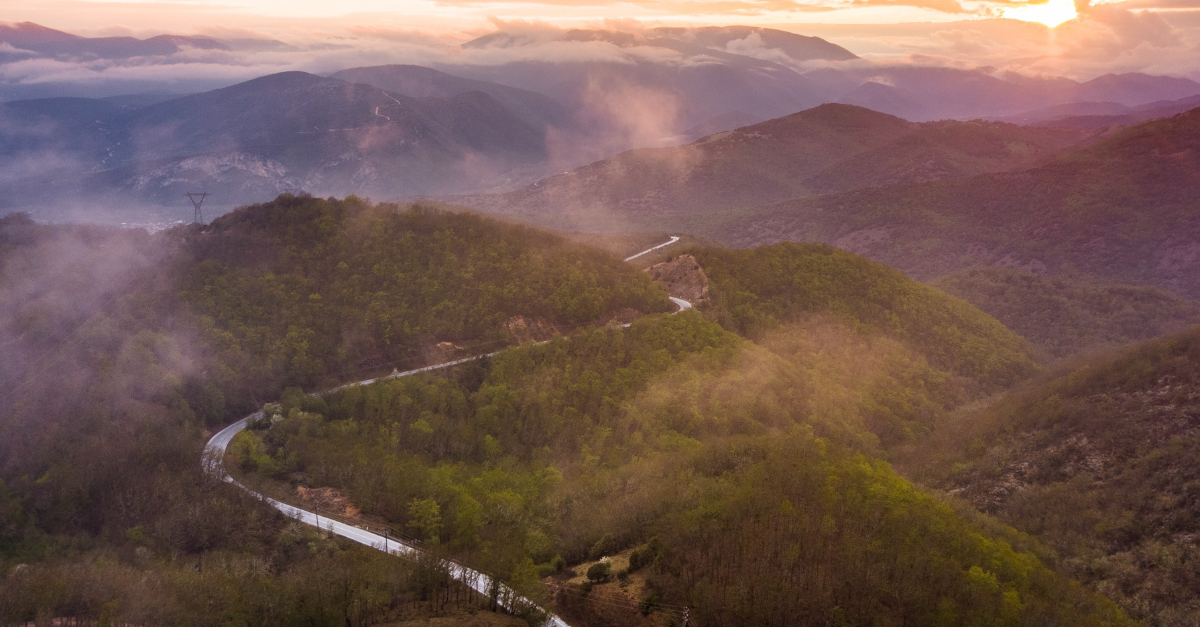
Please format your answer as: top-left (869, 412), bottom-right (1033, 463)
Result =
top-left (228, 246), bottom-right (1126, 625)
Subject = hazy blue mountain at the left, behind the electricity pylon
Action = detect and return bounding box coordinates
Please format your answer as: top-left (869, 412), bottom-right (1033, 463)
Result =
top-left (0, 72), bottom-right (546, 209)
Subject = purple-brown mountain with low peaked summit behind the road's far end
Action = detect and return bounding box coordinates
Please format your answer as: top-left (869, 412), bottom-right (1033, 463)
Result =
top-left (461, 105), bottom-right (1086, 230)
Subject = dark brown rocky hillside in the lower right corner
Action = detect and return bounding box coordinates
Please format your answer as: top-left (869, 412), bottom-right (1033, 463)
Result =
top-left (911, 329), bottom-right (1200, 625)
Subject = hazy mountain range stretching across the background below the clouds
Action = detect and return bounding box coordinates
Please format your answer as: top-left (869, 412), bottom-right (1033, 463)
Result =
top-left (7, 24), bottom-right (1200, 222)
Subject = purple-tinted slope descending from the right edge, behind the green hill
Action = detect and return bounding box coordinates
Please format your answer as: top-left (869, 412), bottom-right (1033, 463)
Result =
top-left (720, 104), bottom-right (1200, 298)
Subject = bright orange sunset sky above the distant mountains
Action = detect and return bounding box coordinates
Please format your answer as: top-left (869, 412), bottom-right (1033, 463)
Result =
top-left (0, 0), bottom-right (1200, 79)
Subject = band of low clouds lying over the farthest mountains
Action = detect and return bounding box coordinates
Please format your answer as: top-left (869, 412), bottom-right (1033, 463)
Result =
top-left (0, 11), bottom-right (1200, 98)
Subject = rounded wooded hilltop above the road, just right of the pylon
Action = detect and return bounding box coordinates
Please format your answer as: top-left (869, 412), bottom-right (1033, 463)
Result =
top-left (180, 196), bottom-right (673, 386)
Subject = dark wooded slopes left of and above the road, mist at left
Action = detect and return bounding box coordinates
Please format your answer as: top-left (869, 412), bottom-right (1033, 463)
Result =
top-left (0, 196), bottom-right (672, 625)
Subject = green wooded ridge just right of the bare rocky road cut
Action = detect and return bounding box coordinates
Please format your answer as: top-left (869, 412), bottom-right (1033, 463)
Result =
top-left (694, 243), bottom-right (1037, 389)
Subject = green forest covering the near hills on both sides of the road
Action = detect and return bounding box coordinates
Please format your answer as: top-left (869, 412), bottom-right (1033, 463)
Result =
top-left (0, 195), bottom-right (1180, 627)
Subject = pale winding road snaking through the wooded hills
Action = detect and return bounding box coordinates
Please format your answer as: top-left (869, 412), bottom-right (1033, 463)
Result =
top-left (203, 235), bottom-right (691, 627)
